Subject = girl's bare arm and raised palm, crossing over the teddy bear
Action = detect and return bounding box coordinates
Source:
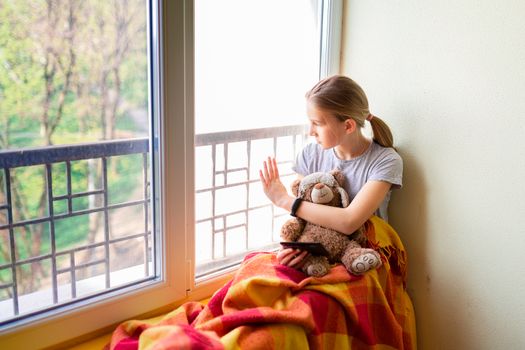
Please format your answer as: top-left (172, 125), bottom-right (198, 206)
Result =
top-left (259, 158), bottom-right (391, 234)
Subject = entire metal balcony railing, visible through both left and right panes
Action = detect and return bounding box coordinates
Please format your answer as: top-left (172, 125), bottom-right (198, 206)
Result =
top-left (0, 125), bottom-right (306, 325)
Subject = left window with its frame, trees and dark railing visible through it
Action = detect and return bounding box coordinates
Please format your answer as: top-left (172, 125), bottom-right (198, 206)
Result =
top-left (0, 0), bottom-right (191, 348)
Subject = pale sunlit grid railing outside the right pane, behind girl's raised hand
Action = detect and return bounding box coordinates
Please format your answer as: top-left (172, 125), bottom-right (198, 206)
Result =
top-left (195, 125), bottom-right (307, 278)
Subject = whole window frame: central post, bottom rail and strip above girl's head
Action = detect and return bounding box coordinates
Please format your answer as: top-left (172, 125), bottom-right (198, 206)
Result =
top-left (0, 0), bottom-right (342, 349)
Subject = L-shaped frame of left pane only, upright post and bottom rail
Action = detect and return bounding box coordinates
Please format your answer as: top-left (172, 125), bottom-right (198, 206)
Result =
top-left (0, 0), bottom-right (193, 348)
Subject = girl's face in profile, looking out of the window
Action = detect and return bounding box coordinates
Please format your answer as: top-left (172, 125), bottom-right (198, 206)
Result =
top-left (306, 103), bottom-right (346, 149)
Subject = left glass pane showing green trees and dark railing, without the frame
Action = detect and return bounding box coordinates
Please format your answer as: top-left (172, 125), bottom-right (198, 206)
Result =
top-left (0, 0), bottom-right (158, 324)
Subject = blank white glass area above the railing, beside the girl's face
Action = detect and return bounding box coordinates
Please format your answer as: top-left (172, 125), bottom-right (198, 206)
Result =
top-left (195, 0), bottom-right (320, 134)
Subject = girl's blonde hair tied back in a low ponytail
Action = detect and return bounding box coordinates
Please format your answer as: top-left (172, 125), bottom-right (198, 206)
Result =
top-left (306, 75), bottom-right (394, 148)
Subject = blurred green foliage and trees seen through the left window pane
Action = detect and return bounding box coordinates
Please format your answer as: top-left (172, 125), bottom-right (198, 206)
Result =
top-left (0, 0), bottom-right (148, 299)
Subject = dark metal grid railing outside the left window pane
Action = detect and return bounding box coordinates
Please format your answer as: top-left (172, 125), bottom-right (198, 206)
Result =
top-left (0, 138), bottom-right (152, 324)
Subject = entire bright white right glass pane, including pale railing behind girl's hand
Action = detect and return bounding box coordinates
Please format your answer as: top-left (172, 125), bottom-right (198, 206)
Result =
top-left (195, 0), bottom-right (321, 277)
